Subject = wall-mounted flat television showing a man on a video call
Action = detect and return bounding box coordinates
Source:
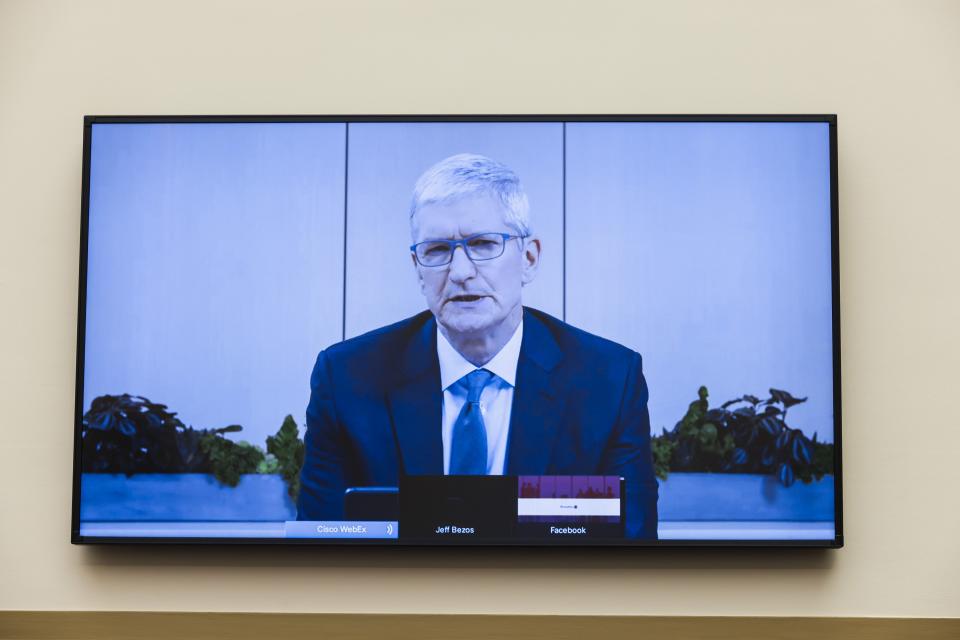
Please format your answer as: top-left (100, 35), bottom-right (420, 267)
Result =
top-left (72, 116), bottom-right (842, 547)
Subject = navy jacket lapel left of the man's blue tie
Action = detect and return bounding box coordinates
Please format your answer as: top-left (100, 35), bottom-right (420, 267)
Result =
top-left (387, 315), bottom-right (443, 475)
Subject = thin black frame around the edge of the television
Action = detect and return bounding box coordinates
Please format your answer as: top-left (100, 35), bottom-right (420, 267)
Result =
top-left (70, 114), bottom-right (844, 549)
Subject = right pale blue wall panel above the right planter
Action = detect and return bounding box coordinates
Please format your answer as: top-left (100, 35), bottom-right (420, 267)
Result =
top-left (567, 123), bottom-right (833, 441)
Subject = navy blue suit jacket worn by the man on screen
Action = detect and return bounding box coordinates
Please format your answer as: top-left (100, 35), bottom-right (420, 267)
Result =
top-left (298, 308), bottom-right (657, 539)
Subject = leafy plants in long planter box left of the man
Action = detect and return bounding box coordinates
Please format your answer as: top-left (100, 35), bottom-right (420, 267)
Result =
top-left (81, 394), bottom-right (304, 521)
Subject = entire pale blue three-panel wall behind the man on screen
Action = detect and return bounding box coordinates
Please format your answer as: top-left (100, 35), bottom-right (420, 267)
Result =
top-left (84, 123), bottom-right (833, 444)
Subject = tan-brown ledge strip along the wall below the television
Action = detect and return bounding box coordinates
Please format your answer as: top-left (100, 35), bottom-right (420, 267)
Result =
top-left (0, 611), bottom-right (960, 640)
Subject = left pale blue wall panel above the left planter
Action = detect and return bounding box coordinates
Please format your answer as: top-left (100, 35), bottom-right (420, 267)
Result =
top-left (84, 124), bottom-right (345, 445)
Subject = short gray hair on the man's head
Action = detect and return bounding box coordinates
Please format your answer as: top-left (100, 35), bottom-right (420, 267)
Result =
top-left (410, 153), bottom-right (531, 241)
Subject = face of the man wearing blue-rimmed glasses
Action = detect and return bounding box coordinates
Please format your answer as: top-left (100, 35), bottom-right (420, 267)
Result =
top-left (413, 195), bottom-right (540, 334)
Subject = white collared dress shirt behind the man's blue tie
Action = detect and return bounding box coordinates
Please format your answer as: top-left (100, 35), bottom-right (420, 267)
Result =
top-left (437, 320), bottom-right (523, 476)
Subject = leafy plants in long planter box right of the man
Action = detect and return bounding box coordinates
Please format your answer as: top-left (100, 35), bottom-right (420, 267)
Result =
top-left (651, 387), bottom-right (834, 521)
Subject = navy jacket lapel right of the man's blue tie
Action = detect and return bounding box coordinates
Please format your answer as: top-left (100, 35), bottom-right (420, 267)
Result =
top-left (506, 310), bottom-right (565, 475)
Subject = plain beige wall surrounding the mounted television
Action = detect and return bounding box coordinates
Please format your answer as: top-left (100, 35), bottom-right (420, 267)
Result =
top-left (0, 0), bottom-right (960, 616)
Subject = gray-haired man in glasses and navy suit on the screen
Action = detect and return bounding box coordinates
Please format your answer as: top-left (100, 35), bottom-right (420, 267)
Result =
top-left (298, 154), bottom-right (657, 538)
